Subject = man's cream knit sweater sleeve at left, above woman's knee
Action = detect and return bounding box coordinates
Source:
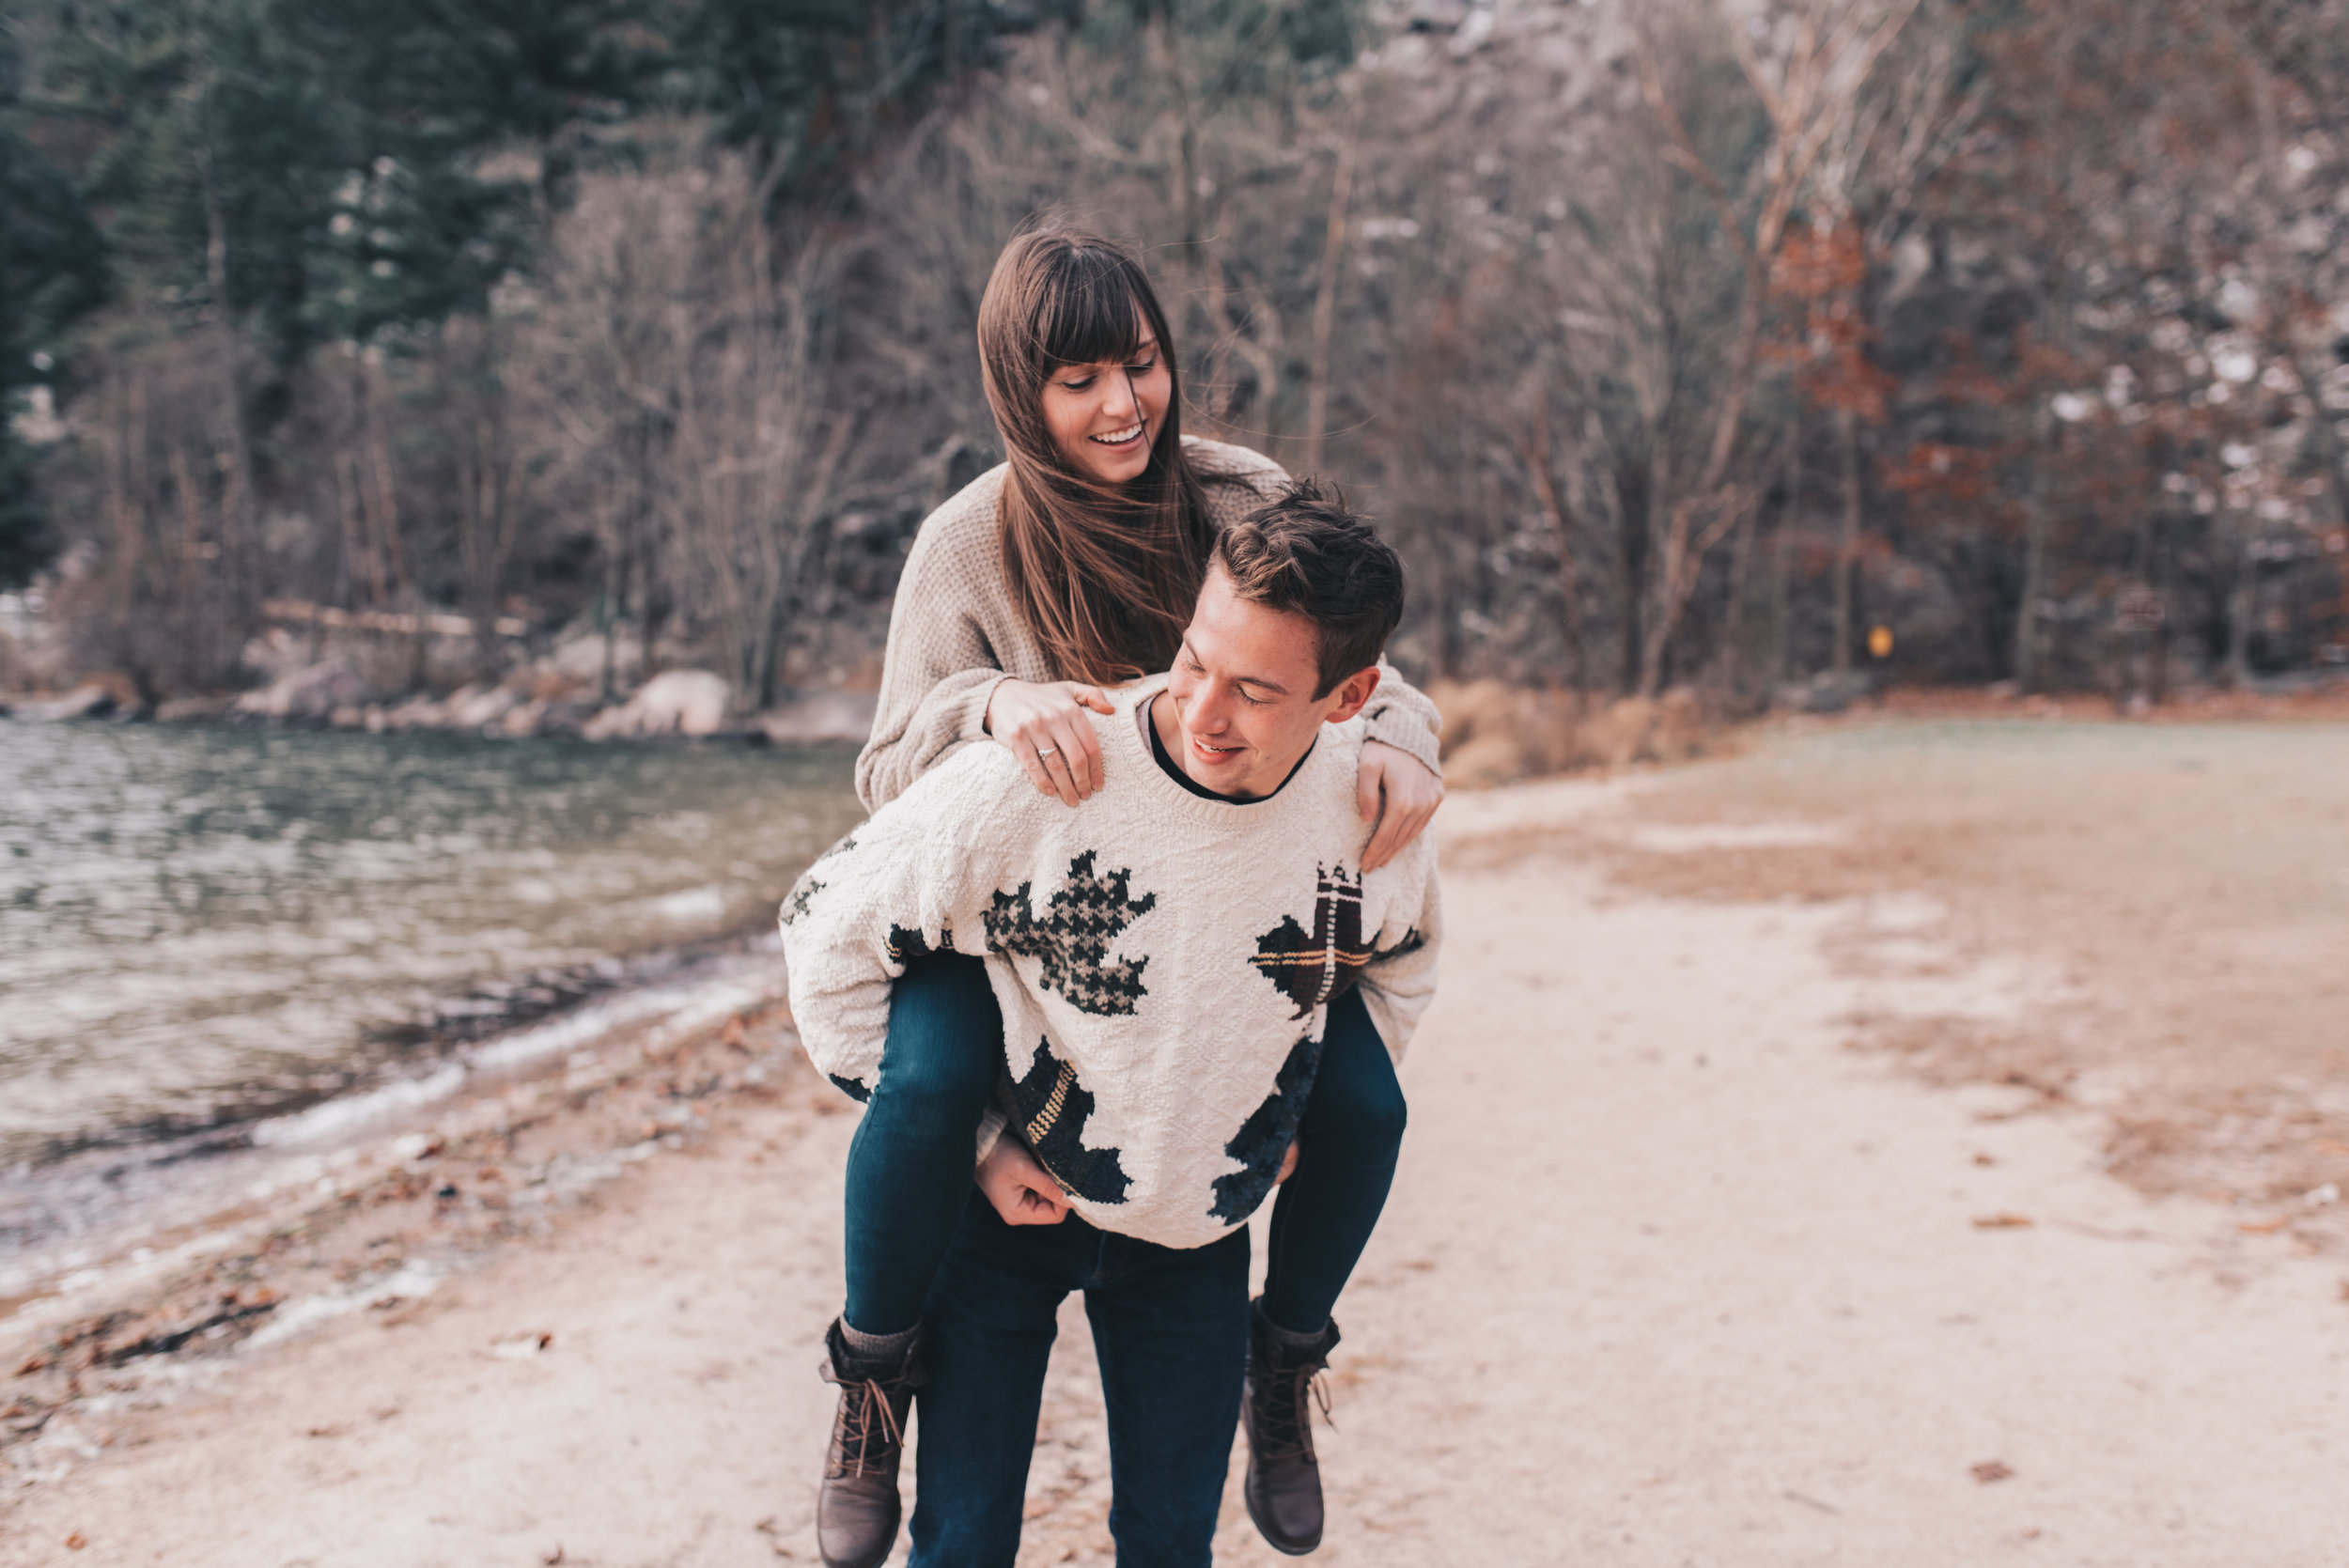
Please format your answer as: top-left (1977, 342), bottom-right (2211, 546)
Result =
top-left (783, 753), bottom-right (1019, 1101)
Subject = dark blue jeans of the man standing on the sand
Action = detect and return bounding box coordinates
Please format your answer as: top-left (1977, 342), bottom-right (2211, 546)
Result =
top-left (910, 1192), bottom-right (1248, 1568)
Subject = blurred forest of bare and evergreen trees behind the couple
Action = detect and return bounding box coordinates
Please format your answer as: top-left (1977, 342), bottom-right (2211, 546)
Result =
top-left (0, 0), bottom-right (2349, 714)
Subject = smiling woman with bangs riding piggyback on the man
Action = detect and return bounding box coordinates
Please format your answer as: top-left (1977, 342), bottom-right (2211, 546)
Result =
top-left (817, 232), bottom-right (1442, 1563)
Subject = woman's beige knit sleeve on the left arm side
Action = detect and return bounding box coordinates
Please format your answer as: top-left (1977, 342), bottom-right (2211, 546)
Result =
top-left (858, 495), bottom-right (1005, 812)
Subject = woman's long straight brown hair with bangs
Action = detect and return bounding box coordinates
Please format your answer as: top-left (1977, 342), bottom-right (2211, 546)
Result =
top-left (980, 230), bottom-right (1215, 683)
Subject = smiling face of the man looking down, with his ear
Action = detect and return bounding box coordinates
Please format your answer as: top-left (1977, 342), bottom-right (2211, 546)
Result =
top-left (1151, 566), bottom-right (1379, 796)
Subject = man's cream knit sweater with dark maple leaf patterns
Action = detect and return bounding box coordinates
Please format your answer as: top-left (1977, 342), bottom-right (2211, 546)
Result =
top-left (783, 676), bottom-right (1442, 1247)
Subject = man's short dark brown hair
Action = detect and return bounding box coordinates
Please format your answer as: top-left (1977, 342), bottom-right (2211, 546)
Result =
top-left (1210, 479), bottom-right (1403, 702)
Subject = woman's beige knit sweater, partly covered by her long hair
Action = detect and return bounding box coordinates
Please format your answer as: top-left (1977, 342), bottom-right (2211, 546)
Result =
top-left (858, 437), bottom-right (1442, 810)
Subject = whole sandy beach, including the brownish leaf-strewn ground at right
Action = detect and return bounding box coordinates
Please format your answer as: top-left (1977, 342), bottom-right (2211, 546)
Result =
top-left (0, 725), bottom-right (2349, 1568)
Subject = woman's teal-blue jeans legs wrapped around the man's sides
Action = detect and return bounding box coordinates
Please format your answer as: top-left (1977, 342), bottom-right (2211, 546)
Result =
top-left (846, 953), bottom-right (1405, 1333)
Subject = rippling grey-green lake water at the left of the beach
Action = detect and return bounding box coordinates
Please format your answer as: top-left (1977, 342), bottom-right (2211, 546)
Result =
top-left (0, 723), bottom-right (863, 1169)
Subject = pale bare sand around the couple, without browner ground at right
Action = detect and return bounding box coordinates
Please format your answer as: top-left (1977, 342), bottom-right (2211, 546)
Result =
top-left (0, 727), bottom-right (2349, 1568)
